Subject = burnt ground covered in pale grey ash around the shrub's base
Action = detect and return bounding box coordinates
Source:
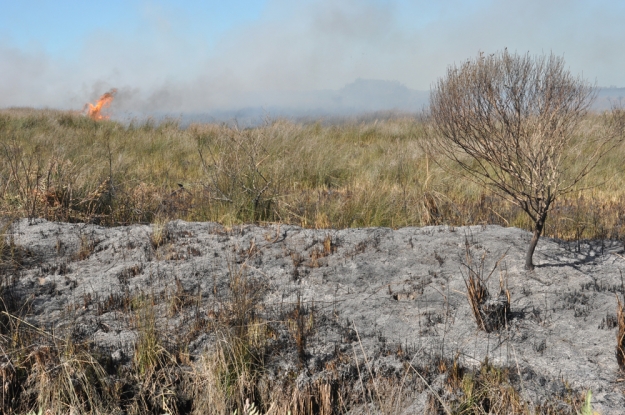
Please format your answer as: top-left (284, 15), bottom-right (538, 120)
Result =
top-left (3, 219), bottom-right (625, 414)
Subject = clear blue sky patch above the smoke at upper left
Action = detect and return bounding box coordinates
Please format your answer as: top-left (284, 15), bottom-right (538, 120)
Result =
top-left (0, 0), bottom-right (266, 57)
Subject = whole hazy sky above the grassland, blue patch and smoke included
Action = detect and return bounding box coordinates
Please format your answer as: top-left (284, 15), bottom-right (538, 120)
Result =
top-left (0, 0), bottom-right (625, 112)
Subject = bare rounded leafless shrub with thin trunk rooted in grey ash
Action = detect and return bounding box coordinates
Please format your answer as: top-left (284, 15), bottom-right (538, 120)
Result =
top-left (426, 50), bottom-right (625, 270)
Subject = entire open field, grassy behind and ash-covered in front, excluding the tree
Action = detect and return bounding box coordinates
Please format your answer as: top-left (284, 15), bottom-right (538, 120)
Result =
top-left (0, 109), bottom-right (625, 415)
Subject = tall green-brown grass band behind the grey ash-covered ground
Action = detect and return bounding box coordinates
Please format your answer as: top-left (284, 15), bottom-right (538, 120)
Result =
top-left (0, 109), bottom-right (625, 239)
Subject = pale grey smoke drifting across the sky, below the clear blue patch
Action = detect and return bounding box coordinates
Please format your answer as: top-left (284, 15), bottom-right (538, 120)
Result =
top-left (0, 0), bottom-right (625, 115)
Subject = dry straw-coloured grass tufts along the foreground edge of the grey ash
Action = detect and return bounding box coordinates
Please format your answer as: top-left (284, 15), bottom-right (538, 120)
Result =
top-left (0, 286), bottom-right (596, 415)
